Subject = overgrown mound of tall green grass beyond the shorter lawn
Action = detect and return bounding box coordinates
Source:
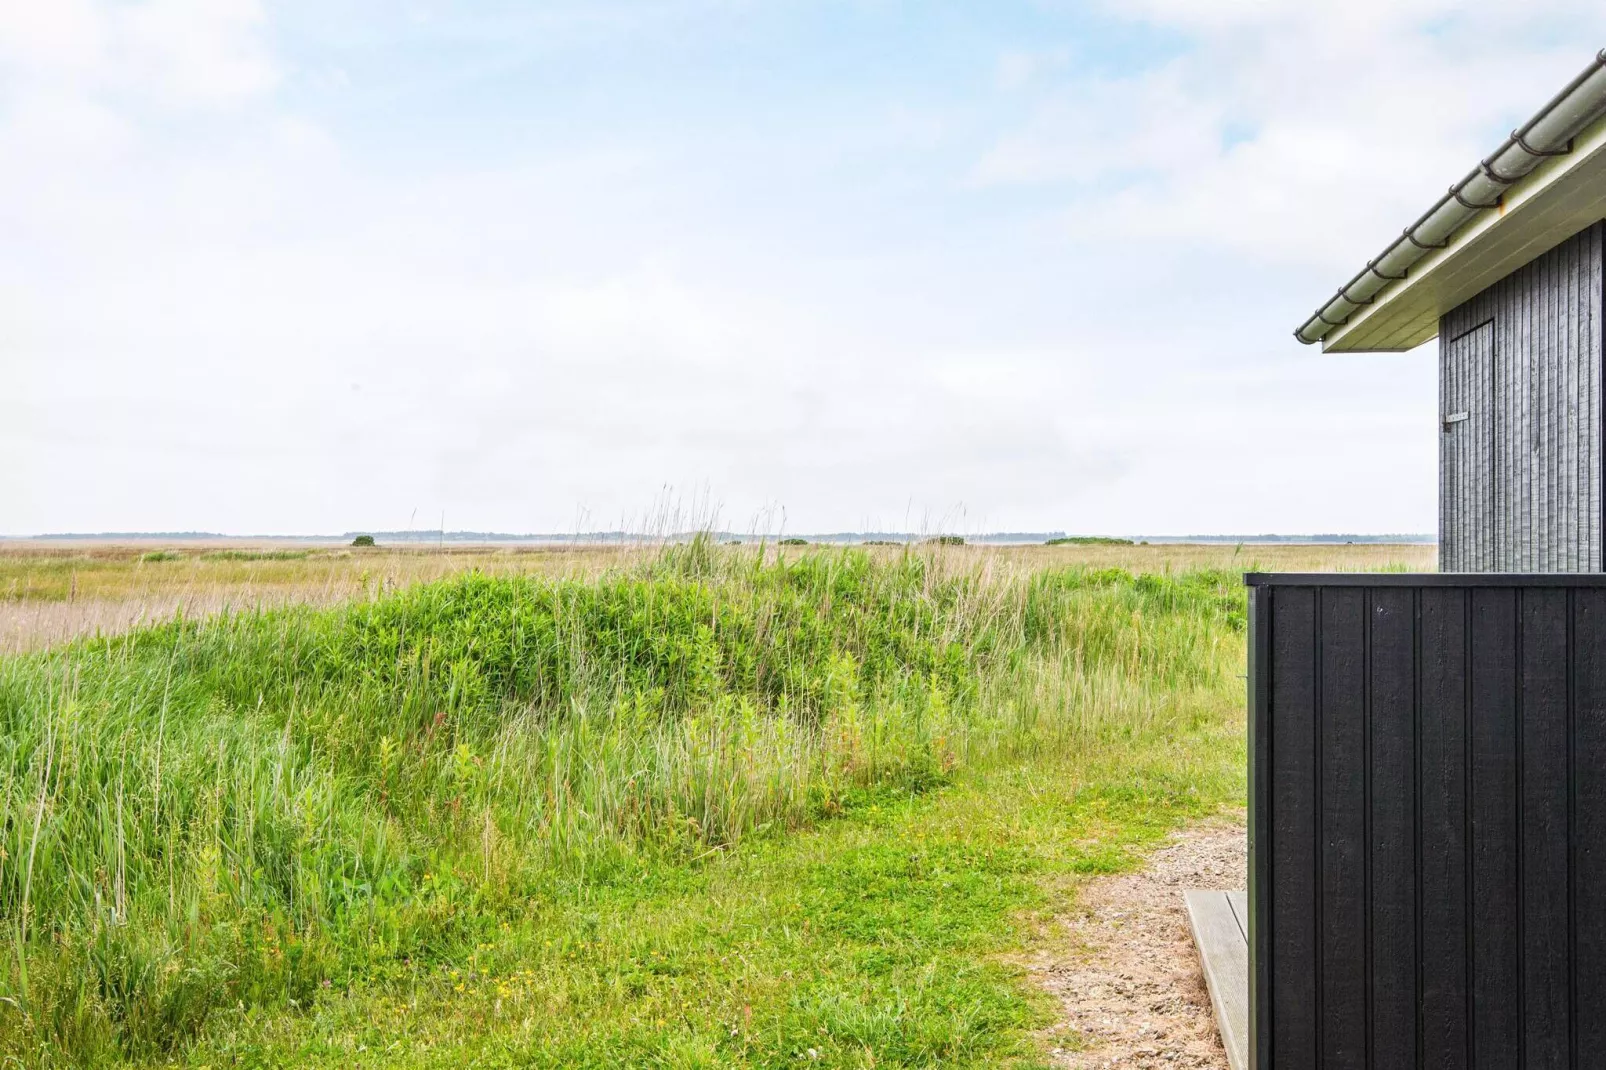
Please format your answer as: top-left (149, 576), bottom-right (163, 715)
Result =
top-left (0, 541), bottom-right (1243, 1065)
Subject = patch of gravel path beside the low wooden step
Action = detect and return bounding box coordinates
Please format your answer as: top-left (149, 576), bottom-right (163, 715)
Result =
top-left (1028, 819), bottom-right (1245, 1070)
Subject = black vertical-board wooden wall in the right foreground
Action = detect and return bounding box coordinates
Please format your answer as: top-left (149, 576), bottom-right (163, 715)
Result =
top-left (1248, 575), bottom-right (1606, 1070)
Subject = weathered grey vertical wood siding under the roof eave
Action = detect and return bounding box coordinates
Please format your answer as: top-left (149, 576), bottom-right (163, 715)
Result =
top-left (1439, 223), bottom-right (1606, 572)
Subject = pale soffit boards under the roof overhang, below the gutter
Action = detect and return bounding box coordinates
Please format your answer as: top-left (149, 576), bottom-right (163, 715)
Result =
top-left (1322, 120), bottom-right (1606, 353)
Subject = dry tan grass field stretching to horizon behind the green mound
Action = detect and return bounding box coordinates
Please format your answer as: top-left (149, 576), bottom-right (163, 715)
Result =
top-left (0, 541), bottom-right (1436, 654)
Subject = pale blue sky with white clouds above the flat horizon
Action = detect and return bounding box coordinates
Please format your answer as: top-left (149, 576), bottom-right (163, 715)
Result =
top-left (0, 0), bottom-right (1606, 535)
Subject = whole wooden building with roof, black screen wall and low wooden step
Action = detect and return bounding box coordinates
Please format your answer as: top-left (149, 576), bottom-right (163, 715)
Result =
top-left (1187, 53), bottom-right (1606, 1070)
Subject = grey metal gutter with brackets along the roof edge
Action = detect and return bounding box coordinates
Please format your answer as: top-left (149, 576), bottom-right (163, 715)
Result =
top-left (1294, 50), bottom-right (1606, 345)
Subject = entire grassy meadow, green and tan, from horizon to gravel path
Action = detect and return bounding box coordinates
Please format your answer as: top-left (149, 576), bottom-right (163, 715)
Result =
top-left (0, 538), bottom-right (1433, 1067)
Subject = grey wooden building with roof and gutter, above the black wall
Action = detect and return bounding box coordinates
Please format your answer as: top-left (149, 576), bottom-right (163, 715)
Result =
top-left (1296, 56), bottom-right (1606, 572)
